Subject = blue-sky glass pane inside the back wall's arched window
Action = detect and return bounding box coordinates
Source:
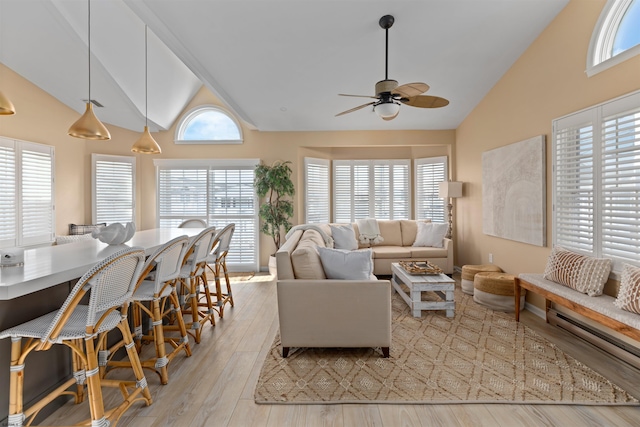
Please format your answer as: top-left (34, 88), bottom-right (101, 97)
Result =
top-left (182, 110), bottom-right (240, 141)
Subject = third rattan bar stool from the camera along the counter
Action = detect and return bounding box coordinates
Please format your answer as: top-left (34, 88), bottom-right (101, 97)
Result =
top-left (174, 227), bottom-right (216, 344)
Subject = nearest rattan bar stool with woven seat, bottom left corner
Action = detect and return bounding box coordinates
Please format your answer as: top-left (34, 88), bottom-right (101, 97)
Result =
top-left (0, 248), bottom-right (152, 427)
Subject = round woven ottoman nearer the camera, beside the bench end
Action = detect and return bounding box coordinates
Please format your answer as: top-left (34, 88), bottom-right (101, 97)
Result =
top-left (473, 272), bottom-right (524, 312)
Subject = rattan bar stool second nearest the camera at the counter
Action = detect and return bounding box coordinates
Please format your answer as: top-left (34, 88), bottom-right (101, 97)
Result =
top-left (100, 236), bottom-right (191, 384)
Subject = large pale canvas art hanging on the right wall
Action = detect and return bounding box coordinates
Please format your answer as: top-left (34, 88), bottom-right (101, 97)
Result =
top-left (482, 135), bottom-right (547, 246)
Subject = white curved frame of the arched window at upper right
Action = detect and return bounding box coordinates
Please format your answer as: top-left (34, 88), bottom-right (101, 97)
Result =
top-left (586, 0), bottom-right (640, 77)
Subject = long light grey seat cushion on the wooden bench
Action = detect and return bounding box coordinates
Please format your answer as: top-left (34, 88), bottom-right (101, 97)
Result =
top-left (518, 273), bottom-right (640, 329)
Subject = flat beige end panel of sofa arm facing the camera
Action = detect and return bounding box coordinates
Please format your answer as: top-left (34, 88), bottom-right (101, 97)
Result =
top-left (277, 279), bottom-right (391, 347)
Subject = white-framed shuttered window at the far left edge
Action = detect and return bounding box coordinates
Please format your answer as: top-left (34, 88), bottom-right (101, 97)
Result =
top-left (0, 137), bottom-right (56, 248)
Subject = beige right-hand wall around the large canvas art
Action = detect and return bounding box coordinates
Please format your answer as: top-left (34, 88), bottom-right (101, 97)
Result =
top-left (455, 0), bottom-right (640, 290)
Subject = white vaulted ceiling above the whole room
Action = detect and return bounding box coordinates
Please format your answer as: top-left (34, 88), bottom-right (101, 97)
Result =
top-left (0, 0), bottom-right (569, 131)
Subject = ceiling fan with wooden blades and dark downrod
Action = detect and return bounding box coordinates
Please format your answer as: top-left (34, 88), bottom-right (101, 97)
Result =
top-left (336, 15), bottom-right (449, 120)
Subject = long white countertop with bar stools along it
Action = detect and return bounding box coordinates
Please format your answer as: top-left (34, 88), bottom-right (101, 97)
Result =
top-left (0, 228), bottom-right (202, 300)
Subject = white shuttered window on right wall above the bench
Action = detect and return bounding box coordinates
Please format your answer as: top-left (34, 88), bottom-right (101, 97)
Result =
top-left (552, 91), bottom-right (640, 278)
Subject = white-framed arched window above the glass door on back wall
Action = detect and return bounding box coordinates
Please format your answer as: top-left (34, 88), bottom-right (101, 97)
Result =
top-left (175, 105), bottom-right (242, 144)
